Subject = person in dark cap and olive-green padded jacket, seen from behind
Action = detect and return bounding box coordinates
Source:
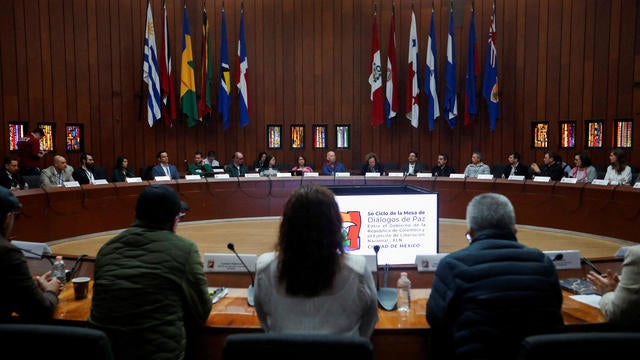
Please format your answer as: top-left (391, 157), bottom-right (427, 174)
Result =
top-left (89, 184), bottom-right (211, 359)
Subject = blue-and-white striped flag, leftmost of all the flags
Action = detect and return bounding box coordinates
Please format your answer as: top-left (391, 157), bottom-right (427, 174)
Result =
top-left (142, 2), bottom-right (162, 126)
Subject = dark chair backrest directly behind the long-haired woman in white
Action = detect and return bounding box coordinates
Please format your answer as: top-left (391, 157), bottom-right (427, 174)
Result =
top-left (222, 333), bottom-right (373, 360)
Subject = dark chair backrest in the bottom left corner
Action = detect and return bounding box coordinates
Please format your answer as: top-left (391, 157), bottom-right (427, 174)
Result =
top-left (0, 323), bottom-right (114, 360)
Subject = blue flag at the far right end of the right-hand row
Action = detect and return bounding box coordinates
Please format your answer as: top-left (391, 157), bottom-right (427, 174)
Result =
top-left (482, 3), bottom-right (500, 131)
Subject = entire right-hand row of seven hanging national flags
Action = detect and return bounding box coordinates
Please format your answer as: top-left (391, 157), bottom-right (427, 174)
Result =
top-left (369, 1), bottom-right (499, 131)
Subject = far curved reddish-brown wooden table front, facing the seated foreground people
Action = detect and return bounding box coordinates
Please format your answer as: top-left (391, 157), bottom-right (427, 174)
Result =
top-left (13, 176), bottom-right (640, 242)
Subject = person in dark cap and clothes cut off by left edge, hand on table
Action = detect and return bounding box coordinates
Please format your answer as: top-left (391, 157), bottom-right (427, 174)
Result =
top-left (0, 187), bottom-right (60, 322)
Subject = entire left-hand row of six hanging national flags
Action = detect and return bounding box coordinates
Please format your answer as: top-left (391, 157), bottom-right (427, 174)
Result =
top-left (142, 1), bottom-right (250, 130)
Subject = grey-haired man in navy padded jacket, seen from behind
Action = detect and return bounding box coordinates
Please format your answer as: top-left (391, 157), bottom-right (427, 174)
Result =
top-left (427, 193), bottom-right (563, 359)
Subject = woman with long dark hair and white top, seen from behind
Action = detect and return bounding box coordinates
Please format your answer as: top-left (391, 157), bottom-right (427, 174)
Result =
top-left (255, 184), bottom-right (378, 338)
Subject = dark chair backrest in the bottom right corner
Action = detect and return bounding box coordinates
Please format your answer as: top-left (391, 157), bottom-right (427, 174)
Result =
top-left (518, 332), bottom-right (640, 360)
